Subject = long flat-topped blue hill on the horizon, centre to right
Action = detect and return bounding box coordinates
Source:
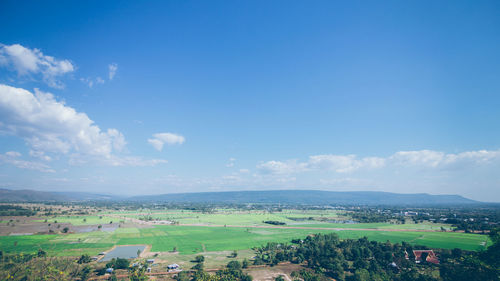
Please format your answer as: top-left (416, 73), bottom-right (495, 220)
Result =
top-left (128, 190), bottom-right (481, 205)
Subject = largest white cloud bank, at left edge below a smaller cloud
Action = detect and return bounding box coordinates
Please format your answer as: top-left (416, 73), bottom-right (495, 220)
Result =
top-left (0, 85), bottom-right (125, 157)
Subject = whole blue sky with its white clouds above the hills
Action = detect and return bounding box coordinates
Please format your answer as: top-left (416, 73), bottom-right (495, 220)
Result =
top-left (0, 1), bottom-right (500, 201)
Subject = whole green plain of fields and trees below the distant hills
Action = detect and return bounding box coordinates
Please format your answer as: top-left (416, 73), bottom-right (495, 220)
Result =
top-left (0, 204), bottom-right (500, 281)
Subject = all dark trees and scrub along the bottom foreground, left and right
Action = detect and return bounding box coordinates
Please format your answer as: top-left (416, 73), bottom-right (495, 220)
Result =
top-left (0, 230), bottom-right (500, 281)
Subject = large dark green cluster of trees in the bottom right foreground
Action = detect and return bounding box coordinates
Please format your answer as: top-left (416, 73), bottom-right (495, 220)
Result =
top-left (254, 228), bottom-right (500, 281)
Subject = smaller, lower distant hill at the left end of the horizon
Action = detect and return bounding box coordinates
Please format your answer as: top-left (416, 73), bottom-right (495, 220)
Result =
top-left (0, 189), bottom-right (116, 202)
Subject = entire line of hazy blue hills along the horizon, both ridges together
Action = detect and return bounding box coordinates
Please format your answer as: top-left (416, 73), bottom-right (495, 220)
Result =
top-left (0, 189), bottom-right (483, 206)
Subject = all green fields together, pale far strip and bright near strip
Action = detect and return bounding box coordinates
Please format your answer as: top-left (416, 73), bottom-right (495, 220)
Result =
top-left (0, 209), bottom-right (490, 256)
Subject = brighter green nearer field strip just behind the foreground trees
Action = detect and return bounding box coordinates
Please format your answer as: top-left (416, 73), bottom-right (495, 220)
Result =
top-left (0, 225), bottom-right (490, 256)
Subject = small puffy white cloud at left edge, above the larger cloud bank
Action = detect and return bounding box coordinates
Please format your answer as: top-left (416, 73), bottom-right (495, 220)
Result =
top-left (0, 44), bottom-right (75, 88)
